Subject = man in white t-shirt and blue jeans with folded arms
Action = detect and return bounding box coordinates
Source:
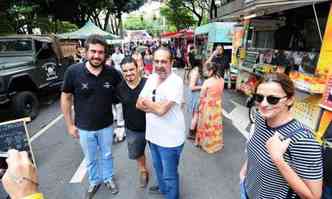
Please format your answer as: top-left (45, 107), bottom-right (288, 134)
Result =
top-left (136, 47), bottom-right (185, 199)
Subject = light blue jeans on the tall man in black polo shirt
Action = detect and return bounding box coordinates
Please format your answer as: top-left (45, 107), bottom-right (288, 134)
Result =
top-left (78, 126), bottom-right (113, 185)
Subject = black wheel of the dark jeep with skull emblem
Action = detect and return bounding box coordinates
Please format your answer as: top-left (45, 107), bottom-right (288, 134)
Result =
top-left (12, 91), bottom-right (39, 120)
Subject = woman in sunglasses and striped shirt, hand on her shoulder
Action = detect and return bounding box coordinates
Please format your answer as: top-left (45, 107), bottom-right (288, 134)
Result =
top-left (240, 73), bottom-right (322, 199)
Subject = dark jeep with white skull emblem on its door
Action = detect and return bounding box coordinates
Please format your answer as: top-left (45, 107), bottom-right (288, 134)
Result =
top-left (0, 35), bottom-right (74, 119)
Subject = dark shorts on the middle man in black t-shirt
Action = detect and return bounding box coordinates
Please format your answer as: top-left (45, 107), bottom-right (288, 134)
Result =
top-left (126, 128), bottom-right (146, 160)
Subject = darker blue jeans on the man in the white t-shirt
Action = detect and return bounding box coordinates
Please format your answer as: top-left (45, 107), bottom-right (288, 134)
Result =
top-left (149, 142), bottom-right (183, 199)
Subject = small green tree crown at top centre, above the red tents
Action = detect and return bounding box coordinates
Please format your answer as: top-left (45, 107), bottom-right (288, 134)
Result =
top-left (160, 0), bottom-right (196, 30)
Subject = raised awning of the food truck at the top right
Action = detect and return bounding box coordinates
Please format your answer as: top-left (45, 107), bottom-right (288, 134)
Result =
top-left (214, 0), bottom-right (329, 21)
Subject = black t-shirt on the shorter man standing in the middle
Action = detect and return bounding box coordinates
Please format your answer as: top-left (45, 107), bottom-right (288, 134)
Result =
top-left (117, 78), bottom-right (146, 132)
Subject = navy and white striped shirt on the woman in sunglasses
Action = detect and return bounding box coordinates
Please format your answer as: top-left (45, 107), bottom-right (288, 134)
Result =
top-left (245, 113), bottom-right (323, 199)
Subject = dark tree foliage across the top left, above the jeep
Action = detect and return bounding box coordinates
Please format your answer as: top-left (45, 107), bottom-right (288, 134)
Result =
top-left (0, 0), bottom-right (144, 33)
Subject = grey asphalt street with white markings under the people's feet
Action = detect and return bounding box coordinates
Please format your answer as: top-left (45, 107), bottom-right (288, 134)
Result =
top-left (0, 70), bottom-right (249, 199)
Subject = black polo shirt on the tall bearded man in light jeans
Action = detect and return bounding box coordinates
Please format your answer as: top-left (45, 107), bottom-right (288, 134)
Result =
top-left (62, 63), bottom-right (122, 131)
